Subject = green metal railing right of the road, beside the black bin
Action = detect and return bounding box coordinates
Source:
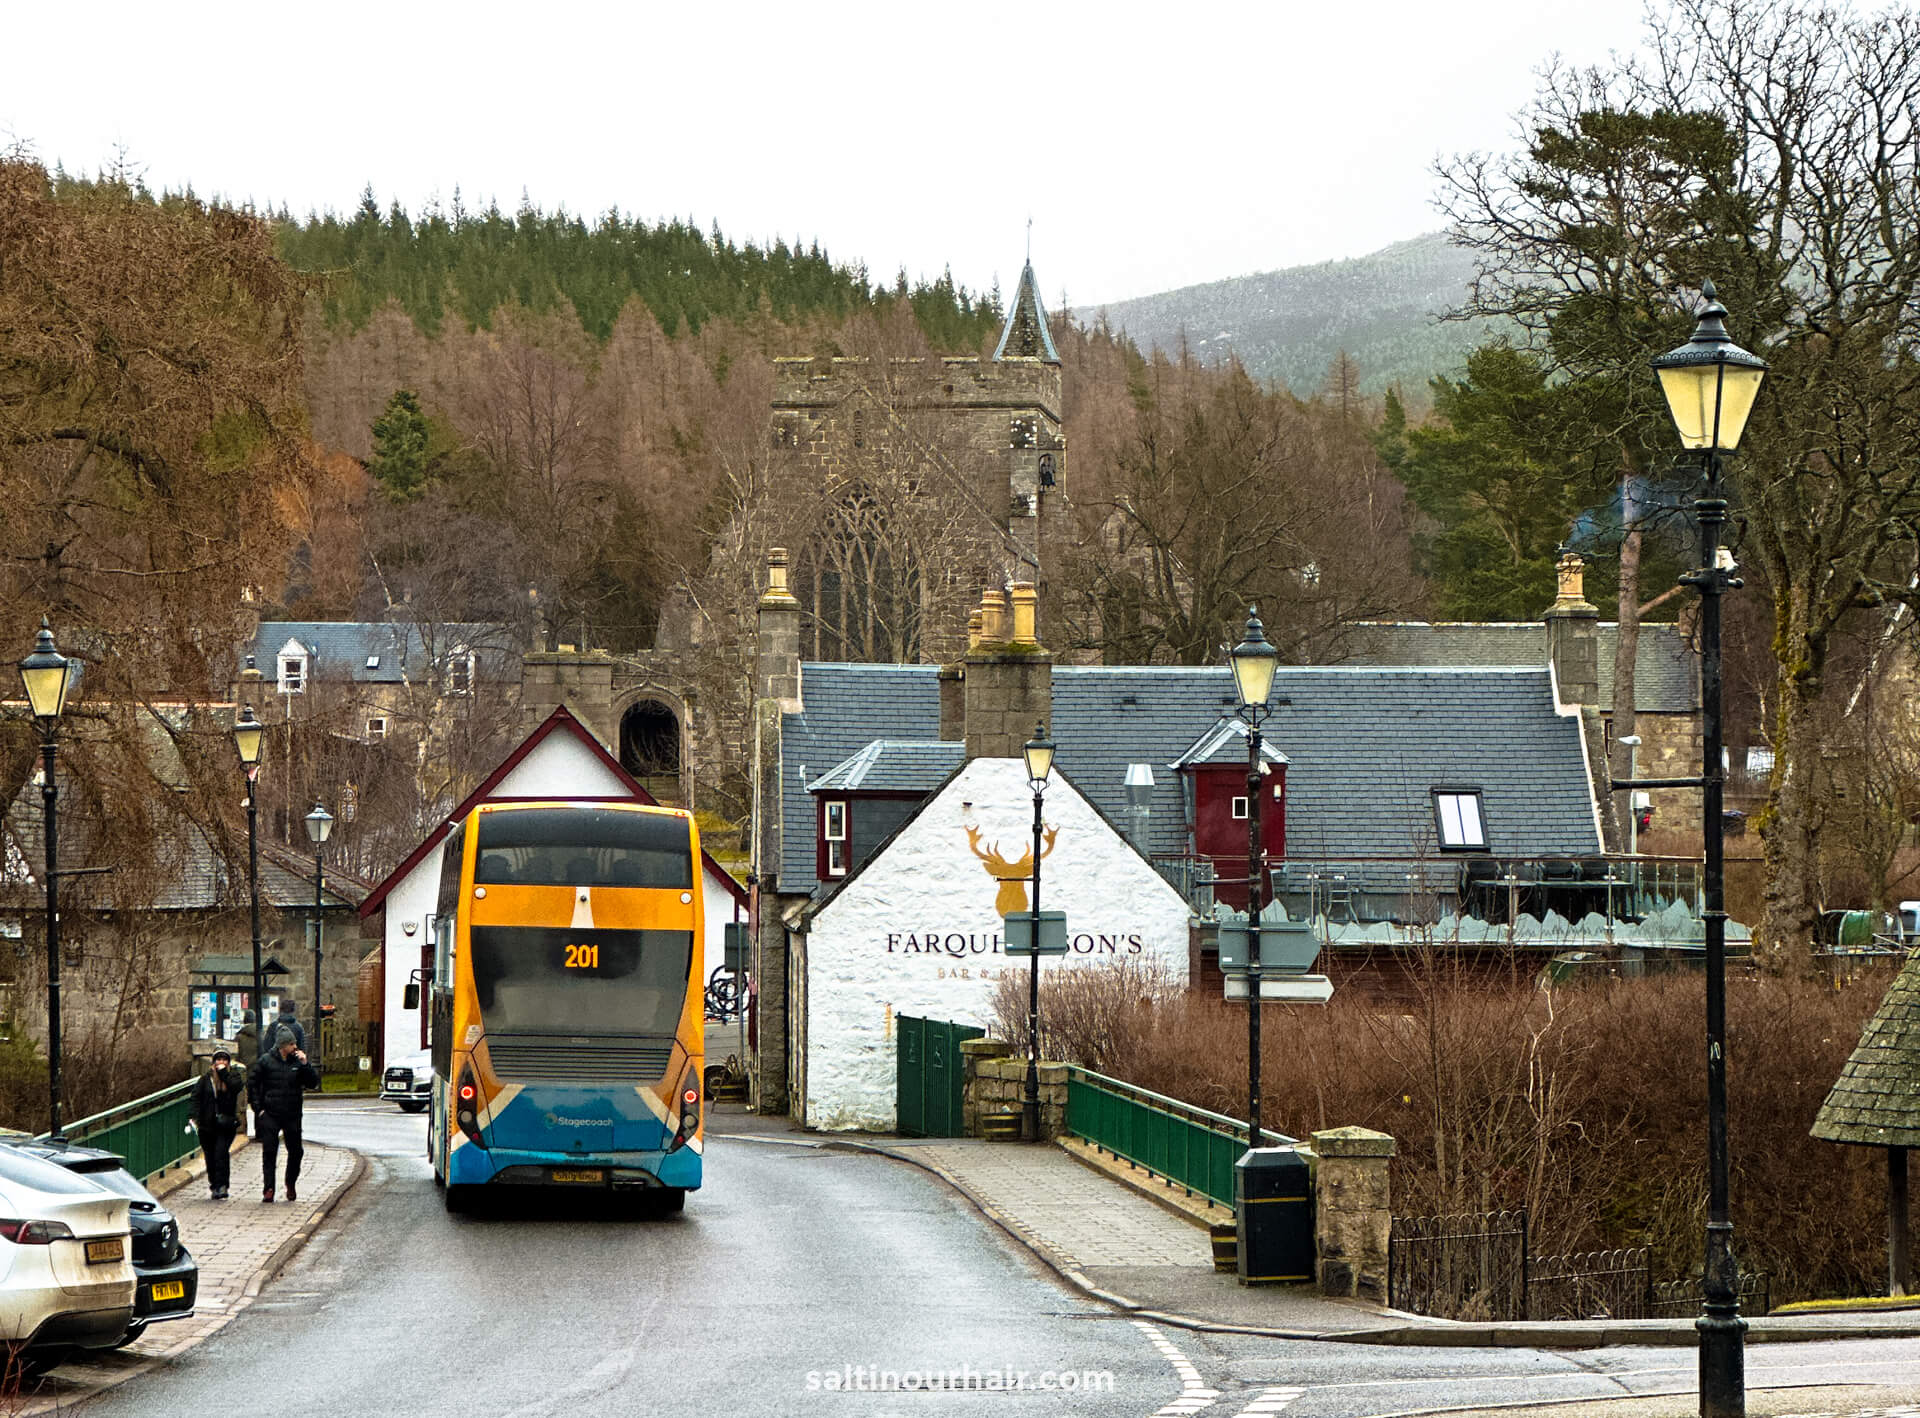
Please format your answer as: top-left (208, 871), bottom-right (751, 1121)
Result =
top-left (1068, 1067), bottom-right (1294, 1207)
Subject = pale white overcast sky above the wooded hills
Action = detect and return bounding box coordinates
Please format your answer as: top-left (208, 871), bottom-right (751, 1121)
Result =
top-left (0, 0), bottom-right (1642, 309)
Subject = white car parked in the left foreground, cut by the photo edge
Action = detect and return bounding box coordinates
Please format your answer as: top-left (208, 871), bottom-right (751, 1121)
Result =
top-left (0, 1147), bottom-right (136, 1370)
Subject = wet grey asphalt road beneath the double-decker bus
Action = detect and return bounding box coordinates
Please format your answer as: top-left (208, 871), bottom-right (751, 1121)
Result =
top-left (67, 1103), bottom-right (1920, 1418)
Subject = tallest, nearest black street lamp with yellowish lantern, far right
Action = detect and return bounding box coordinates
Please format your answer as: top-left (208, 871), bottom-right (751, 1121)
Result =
top-left (1651, 280), bottom-right (1766, 1418)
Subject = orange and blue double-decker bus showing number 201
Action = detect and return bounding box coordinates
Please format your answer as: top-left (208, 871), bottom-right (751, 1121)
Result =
top-left (426, 802), bottom-right (705, 1211)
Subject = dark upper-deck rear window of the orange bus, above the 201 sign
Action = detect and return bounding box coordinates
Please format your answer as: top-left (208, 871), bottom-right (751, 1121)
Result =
top-left (474, 808), bottom-right (693, 890)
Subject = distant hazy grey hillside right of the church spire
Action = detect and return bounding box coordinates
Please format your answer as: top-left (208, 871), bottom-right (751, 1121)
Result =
top-left (1077, 232), bottom-right (1486, 395)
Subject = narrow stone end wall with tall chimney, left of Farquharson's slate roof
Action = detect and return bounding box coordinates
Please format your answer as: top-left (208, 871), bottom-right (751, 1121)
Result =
top-left (749, 547), bottom-right (801, 1113)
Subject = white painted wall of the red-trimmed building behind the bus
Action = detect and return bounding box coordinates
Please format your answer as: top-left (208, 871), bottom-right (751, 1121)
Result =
top-left (382, 731), bottom-right (747, 1059)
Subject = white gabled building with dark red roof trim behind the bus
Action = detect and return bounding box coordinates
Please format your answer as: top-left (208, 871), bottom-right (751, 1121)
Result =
top-left (359, 706), bottom-right (747, 1071)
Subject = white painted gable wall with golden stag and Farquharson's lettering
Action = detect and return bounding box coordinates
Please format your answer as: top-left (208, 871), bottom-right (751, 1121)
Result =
top-left (806, 758), bottom-right (1188, 1132)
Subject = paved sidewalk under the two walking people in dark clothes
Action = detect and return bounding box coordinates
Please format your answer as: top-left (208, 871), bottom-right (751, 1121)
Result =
top-left (19, 1142), bottom-right (365, 1414)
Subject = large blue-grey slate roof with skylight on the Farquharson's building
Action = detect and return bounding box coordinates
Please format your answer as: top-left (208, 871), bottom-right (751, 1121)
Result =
top-left (780, 664), bottom-right (1601, 892)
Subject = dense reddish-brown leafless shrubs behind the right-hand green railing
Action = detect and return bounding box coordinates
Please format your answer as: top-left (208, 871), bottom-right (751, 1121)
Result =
top-left (1113, 952), bottom-right (1887, 1301)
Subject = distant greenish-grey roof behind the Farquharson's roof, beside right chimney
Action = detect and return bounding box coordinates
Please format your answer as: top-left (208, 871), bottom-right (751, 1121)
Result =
top-left (1340, 620), bottom-right (1699, 714)
